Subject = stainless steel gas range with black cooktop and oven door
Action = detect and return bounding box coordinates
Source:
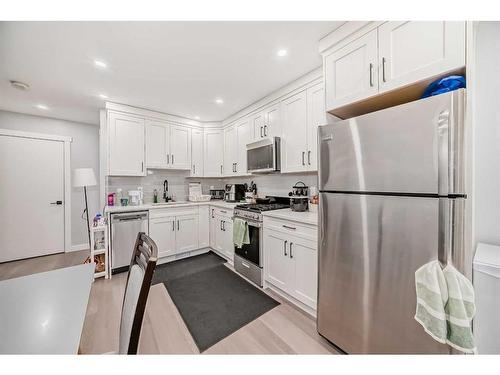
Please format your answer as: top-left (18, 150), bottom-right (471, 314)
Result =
top-left (234, 197), bottom-right (290, 286)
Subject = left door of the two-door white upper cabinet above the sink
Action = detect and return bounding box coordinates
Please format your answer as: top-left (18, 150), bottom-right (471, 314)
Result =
top-left (146, 120), bottom-right (170, 168)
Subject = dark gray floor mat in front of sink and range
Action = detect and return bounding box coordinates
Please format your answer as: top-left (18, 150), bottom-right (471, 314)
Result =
top-left (153, 252), bottom-right (279, 352)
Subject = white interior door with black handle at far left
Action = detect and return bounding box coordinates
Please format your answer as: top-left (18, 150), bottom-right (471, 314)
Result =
top-left (0, 135), bottom-right (65, 262)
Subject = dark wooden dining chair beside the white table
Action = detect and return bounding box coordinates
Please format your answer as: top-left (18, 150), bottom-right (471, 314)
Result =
top-left (118, 232), bottom-right (158, 354)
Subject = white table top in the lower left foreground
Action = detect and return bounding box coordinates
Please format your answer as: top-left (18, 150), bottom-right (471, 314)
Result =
top-left (0, 263), bottom-right (95, 354)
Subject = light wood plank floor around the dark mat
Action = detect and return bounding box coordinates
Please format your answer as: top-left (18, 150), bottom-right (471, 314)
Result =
top-left (0, 251), bottom-right (337, 354)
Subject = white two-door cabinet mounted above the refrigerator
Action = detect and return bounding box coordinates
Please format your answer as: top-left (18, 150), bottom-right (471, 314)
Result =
top-left (323, 21), bottom-right (466, 113)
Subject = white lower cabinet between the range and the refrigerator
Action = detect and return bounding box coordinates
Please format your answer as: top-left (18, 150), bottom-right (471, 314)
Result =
top-left (264, 219), bottom-right (318, 310)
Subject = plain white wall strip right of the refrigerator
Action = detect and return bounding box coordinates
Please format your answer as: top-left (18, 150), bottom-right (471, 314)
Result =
top-left (474, 22), bottom-right (500, 245)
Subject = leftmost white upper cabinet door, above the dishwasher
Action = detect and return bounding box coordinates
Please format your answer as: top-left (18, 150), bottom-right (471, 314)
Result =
top-left (108, 112), bottom-right (146, 176)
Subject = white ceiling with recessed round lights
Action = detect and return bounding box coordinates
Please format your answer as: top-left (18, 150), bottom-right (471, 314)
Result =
top-left (0, 21), bottom-right (342, 124)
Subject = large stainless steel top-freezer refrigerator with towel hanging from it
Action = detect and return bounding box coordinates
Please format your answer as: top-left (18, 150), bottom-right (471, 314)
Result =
top-left (317, 89), bottom-right (470, 353)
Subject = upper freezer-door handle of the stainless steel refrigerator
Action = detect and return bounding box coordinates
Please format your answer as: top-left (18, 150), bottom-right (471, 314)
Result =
top-left (437, 110), bottom-right (451, 195)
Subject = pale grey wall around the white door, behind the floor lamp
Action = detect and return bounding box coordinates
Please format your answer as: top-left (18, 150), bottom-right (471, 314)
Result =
top-left (0, 111), bottom-right (99, 250)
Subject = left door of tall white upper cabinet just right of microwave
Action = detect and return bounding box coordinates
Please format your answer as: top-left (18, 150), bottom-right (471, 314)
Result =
top-left (281, 91), bottom-right (307, 173)
